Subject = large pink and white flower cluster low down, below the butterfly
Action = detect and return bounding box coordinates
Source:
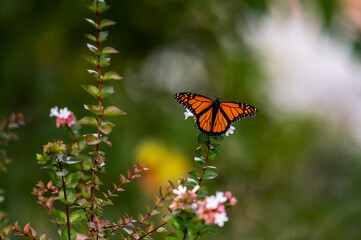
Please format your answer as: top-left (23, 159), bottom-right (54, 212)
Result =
top-left (170, 185), bottom-right (237, 227)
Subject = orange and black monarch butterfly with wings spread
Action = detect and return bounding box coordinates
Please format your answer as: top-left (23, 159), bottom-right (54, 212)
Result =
top-left (174, 93), bottom-right (258, 137)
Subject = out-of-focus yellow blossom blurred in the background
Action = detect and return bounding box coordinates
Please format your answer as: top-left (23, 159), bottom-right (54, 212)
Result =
top-left (135, 140), bottom-right (191, 194)
